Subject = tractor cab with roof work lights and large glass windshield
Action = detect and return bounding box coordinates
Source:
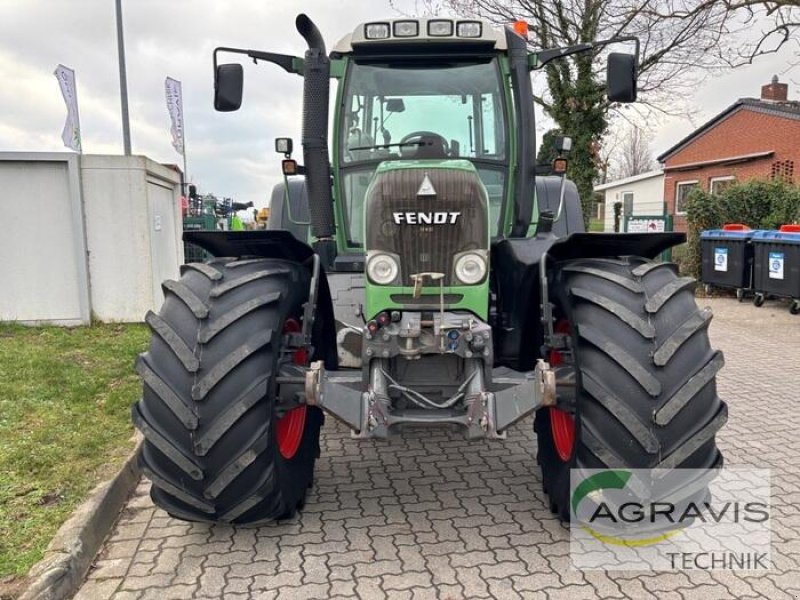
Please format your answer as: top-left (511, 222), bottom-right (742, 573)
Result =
top-left (332, 19), bottom-right (512, 250)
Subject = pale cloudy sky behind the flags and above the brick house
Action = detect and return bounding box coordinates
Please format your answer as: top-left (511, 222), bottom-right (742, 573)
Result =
top-left (0, 0), bottom-right (800, 207)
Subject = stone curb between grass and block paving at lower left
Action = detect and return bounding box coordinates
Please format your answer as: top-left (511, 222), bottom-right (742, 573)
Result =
top-left (18, 436), bottom-right (142, 600)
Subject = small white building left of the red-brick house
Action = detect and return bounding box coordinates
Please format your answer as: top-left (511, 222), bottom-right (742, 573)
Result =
top-left (594, 169), bottom-right (664, 231)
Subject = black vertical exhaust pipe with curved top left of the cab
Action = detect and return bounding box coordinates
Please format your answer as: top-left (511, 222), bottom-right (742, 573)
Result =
top-left (295, 14), bottom-right (336, 267)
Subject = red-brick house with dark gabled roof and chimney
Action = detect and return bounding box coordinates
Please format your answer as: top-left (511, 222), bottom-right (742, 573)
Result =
top-left (658, 76), bottom-right (800, 231)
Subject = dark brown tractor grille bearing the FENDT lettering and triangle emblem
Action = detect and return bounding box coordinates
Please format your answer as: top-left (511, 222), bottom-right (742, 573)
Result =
top-left (366, 167), bottom-right (489, 286)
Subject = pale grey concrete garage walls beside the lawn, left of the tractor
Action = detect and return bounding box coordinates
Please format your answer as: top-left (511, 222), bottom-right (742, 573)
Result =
top-left (0, 152), bottom-right (183, 325)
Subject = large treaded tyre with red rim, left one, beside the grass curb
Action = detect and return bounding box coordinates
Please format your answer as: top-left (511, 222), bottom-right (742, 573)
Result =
top-left (133, 259), bottom-right (323, 523)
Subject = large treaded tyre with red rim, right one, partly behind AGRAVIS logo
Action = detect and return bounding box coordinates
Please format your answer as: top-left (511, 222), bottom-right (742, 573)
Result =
top-left (534, 258), bottom-right (728, 521)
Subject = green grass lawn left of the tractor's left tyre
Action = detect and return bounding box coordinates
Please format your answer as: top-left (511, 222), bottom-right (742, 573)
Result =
top-left (0, 324), bottom-right (149, 580)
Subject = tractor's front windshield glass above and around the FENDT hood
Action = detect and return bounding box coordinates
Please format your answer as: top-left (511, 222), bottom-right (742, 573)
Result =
top-left (339, 59), bottom-right (506, 246)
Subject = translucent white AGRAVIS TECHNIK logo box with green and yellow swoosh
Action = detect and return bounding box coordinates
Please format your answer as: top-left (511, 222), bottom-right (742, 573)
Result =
top-left (570, 469), bottom-right (770, 569)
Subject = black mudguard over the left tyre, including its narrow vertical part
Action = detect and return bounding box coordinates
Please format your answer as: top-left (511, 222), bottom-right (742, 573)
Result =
top-left (183, 229), bottom-right (338, 369)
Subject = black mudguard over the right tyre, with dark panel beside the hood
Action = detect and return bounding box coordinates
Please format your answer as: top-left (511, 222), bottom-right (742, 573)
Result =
top-left (491, 232), bottom-right (686, 370)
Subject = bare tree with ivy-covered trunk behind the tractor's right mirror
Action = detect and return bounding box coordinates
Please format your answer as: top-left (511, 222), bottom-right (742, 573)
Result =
top-left (410, 0), bottom-right (800, 223)
